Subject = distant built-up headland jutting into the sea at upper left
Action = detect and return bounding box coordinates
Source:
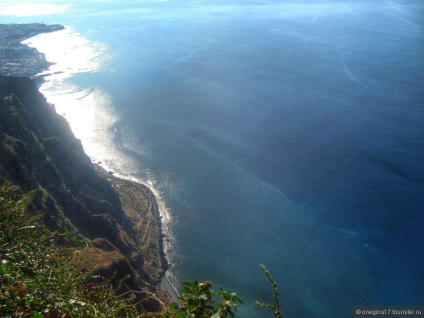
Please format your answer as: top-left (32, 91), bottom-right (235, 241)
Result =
top-left (0, 23), bottom-right (64, 76)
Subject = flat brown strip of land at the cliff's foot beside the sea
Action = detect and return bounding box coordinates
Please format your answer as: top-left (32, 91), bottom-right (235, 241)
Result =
top-left (93, 163), bottom-right (179, 304)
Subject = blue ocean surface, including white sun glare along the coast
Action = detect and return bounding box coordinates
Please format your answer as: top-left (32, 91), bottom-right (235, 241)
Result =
top-left (4, 0), bottom-right (424, 318)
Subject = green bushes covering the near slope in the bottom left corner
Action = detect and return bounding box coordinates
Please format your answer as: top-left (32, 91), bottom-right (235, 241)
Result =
top-left (0, 186), bottom-right (138, 317)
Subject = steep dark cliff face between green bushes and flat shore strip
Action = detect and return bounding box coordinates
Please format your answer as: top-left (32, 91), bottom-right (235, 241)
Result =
top-left (0, 76), bottom-right (166, 310)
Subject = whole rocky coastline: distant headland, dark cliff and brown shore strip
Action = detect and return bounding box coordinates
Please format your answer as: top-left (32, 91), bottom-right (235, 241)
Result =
top-left (0, 24), bottom-right (169, 311)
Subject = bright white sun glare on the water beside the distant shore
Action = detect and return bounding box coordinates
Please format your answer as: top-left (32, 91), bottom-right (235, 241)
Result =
top-left (22, 27), bottom-right (116, 168)
